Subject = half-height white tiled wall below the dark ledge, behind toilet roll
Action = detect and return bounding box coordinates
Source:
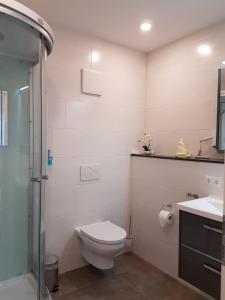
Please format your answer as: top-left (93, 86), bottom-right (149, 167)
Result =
top-left (131, 157), bottom-right (224, 277)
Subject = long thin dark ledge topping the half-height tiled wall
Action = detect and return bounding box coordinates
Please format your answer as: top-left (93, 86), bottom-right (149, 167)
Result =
top-left (131, 153), bottom-right (224, 164)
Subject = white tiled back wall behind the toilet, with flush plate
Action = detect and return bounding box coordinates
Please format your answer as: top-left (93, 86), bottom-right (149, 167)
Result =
top-left (46, 27), bottom-right (146, 272)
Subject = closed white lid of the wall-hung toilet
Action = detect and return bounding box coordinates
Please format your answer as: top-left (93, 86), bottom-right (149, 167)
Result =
top-left (80, 221), bottom-right (127, 245)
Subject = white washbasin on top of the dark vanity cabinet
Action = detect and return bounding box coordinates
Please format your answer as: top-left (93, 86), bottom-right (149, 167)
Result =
top-left (177, 196), bottom-right (223, 222)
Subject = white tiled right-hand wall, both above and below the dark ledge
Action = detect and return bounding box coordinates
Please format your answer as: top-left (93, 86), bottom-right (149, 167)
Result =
top-left (131, 23), bottom-right (225, 284)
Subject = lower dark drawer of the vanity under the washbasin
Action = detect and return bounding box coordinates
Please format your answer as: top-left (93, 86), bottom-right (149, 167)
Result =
top-left (179, 246), bottom-right (221, 299)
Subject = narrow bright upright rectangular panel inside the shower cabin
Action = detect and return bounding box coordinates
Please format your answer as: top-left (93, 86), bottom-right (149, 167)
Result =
top-left (0, 91), bottom-right (8, 146)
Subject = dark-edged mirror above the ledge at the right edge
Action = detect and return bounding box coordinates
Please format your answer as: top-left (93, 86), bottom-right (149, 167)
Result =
top-left (216, 68), bottom-right (225, 151)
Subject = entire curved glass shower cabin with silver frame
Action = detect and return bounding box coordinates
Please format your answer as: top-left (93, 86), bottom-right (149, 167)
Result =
top-left (0, 0), bottom-right (53, 300)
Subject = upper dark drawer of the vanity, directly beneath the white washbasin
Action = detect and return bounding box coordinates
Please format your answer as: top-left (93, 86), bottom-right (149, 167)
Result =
top-left (180, 211), bottom-right (222, 259)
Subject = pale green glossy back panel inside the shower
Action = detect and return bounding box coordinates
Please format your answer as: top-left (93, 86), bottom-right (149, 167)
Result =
top-left (0, 55), bottom-right (29, 281)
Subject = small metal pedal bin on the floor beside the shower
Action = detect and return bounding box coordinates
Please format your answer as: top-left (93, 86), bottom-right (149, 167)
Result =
top-left (45, 254), bottom-right (59, 293)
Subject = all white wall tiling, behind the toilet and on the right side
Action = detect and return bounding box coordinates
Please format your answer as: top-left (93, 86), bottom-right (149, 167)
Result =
top-left (46, 24), bottom-right (225, 276)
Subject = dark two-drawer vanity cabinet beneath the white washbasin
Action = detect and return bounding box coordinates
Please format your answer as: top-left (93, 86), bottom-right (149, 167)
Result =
top-left (179, 211), bottom-right (222, 299)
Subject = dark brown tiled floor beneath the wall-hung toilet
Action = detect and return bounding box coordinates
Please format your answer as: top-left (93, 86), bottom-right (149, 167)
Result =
top-left (53, 254), bottom-right (205, 300)
